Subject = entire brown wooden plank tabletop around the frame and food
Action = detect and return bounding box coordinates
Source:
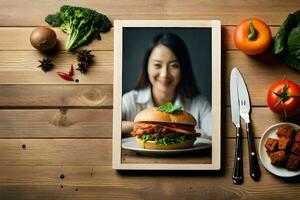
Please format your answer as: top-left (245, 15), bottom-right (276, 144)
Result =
top-left (0, 0), bottom-right (300, 200)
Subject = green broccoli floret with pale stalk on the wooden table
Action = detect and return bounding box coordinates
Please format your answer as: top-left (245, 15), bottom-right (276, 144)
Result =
top-left (45, 5), bottom-right (112, 51)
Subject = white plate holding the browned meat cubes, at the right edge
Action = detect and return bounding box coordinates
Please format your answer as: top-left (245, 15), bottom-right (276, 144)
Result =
top-left (259, 122), bottom-right (300, 177)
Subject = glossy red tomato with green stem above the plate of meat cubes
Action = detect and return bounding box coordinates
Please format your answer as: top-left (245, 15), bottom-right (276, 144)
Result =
top-left (267, 80), bottom-right (300, 117)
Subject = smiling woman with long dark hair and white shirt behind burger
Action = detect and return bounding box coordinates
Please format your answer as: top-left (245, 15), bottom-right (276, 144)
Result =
top-left (122, 32), bottom-right (211, 134)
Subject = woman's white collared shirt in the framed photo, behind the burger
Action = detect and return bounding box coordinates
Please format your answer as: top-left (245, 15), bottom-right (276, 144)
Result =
top-left (122, 87), bottom-right (212, 135)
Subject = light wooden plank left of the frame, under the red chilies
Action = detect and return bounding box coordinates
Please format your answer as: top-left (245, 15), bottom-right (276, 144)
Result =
top-left (0, 51), bottom-right (113, 84)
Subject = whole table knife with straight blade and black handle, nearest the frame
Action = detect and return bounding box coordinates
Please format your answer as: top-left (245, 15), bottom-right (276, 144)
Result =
top-left (230, 68), bottom-right (244, 184)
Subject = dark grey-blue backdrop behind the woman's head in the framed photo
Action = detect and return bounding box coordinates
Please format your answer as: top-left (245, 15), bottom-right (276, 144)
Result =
top-left (122, 27), bottom-right (212, 103)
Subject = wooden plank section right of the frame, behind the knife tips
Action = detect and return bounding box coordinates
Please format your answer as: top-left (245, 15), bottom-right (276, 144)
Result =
top-left (222, 51), bottom-right (300, 106)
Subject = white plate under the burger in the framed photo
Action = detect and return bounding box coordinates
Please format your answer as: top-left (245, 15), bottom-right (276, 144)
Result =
top-left (122, 137), bottom-right (211, 155)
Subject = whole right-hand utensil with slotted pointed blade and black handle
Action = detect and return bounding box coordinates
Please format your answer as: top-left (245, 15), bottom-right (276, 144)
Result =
top-left (236, 69), bottom-right (261, 181)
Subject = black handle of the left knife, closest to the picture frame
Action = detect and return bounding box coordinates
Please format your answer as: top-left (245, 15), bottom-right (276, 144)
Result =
top-left (232, 127), bottom-right (244, 184)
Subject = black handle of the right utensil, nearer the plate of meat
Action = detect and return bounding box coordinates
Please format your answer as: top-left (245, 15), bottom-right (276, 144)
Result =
top-left (246, 123), bottom-right (261, 181)
